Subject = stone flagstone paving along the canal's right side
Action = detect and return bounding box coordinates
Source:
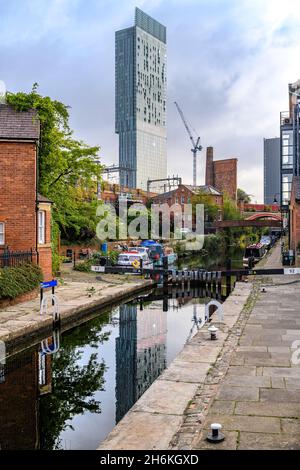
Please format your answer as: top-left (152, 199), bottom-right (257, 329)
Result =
top-left (193, 245), bottom-right (300, 449)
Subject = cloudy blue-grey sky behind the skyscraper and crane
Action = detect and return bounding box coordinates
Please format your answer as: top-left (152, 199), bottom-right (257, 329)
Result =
top-left (0, 0), bottom-right (300, 202)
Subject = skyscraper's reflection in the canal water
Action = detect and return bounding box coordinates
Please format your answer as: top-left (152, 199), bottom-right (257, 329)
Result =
top-left (116, 303), bottom-right (167, 422)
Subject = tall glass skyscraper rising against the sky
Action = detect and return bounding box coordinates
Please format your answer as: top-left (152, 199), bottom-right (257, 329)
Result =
top-left (115, 8), bottom-right (167, 189)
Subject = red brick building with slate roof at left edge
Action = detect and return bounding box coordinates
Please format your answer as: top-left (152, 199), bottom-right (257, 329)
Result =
top-left (0, 105), bottom-right (52, 280)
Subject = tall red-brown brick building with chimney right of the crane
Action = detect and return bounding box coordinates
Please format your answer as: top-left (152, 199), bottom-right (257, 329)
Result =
top-left (205, 147), bottom-right (237, 201)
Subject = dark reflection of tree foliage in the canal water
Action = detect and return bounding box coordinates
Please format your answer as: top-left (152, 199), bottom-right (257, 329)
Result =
top-left (40, 314), bottom-right (110, 449)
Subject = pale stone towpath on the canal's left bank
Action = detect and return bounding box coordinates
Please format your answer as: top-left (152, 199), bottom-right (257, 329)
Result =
top-left (0, 270), bottom-right (152, 344)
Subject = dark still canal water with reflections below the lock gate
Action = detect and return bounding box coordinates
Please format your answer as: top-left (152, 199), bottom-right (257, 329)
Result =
top-left (0, 291), bottom-right (223, 449)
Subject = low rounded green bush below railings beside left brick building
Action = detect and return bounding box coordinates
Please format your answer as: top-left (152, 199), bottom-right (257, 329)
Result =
top-left (0, 263), bottom-right (43, 299)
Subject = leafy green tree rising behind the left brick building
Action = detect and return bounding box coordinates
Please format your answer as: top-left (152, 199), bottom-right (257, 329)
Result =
top-left (7, 84), bottom-right (101, 244)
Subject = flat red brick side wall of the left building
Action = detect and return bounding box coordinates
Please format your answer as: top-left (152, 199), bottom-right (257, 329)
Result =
top-left (0, 142), bottom-right (36, 250)
